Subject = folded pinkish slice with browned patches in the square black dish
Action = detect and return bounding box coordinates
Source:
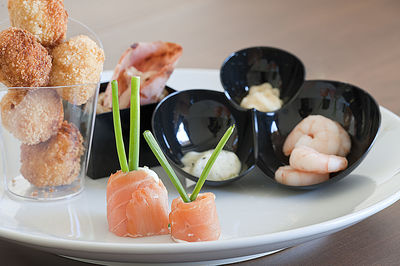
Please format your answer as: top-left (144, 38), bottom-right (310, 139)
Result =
top-left (97, 41), bottom-right (182, 112)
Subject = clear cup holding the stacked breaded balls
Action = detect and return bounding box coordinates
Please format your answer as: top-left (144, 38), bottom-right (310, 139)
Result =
top-left (0, 18), bottom-right (103, 201)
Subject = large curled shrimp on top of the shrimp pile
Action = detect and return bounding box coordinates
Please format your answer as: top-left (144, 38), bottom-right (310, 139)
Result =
top-left (283, 115), bottom-right (341, 156)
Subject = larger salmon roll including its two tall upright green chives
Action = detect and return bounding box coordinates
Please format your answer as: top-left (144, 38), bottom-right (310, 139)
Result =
top-left (107, 77), bottom-right (169, 237)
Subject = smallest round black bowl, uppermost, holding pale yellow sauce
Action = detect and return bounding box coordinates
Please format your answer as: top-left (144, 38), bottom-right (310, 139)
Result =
top-left (220, 46), bottom-right (305, 110)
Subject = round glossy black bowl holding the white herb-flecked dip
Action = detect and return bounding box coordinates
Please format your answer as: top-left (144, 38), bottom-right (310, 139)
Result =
top-left (152, 90), bottom-right (255, 186)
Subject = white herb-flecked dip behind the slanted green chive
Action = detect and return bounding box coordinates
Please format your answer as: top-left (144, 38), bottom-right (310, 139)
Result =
top-left (182, 150), bottom-right (242, 181)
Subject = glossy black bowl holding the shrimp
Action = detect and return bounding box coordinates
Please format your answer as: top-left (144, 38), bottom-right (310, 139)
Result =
top-left (256, 80), bottom-right (381, 189)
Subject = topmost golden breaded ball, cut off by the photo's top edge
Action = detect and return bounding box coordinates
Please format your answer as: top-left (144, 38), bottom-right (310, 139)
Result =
top-left (8, 0), bottom-right (68, 47)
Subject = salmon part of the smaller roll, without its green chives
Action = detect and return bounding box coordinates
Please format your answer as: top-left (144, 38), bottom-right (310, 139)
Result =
top-left (169, 192), bottom-right (221, 242)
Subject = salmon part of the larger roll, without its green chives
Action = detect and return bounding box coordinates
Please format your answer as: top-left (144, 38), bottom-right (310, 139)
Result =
top-left (107, 168), bottom-right (169, 237)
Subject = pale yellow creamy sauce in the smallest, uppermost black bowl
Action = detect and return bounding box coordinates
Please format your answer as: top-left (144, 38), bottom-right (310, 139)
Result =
top-left (240, 82), bottom-right (283, 112)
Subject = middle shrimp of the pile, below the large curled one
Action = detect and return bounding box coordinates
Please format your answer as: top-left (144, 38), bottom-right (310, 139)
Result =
top-left (289, 146), bottom-right (347, 174)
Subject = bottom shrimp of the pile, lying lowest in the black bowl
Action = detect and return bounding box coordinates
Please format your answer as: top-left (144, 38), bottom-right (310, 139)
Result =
top-left (275, 165), bottom-right (329, 186)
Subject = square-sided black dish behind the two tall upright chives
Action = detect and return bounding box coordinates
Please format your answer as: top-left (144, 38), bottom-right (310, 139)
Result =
top-left (87, 83), bottom-right (175, 179)
